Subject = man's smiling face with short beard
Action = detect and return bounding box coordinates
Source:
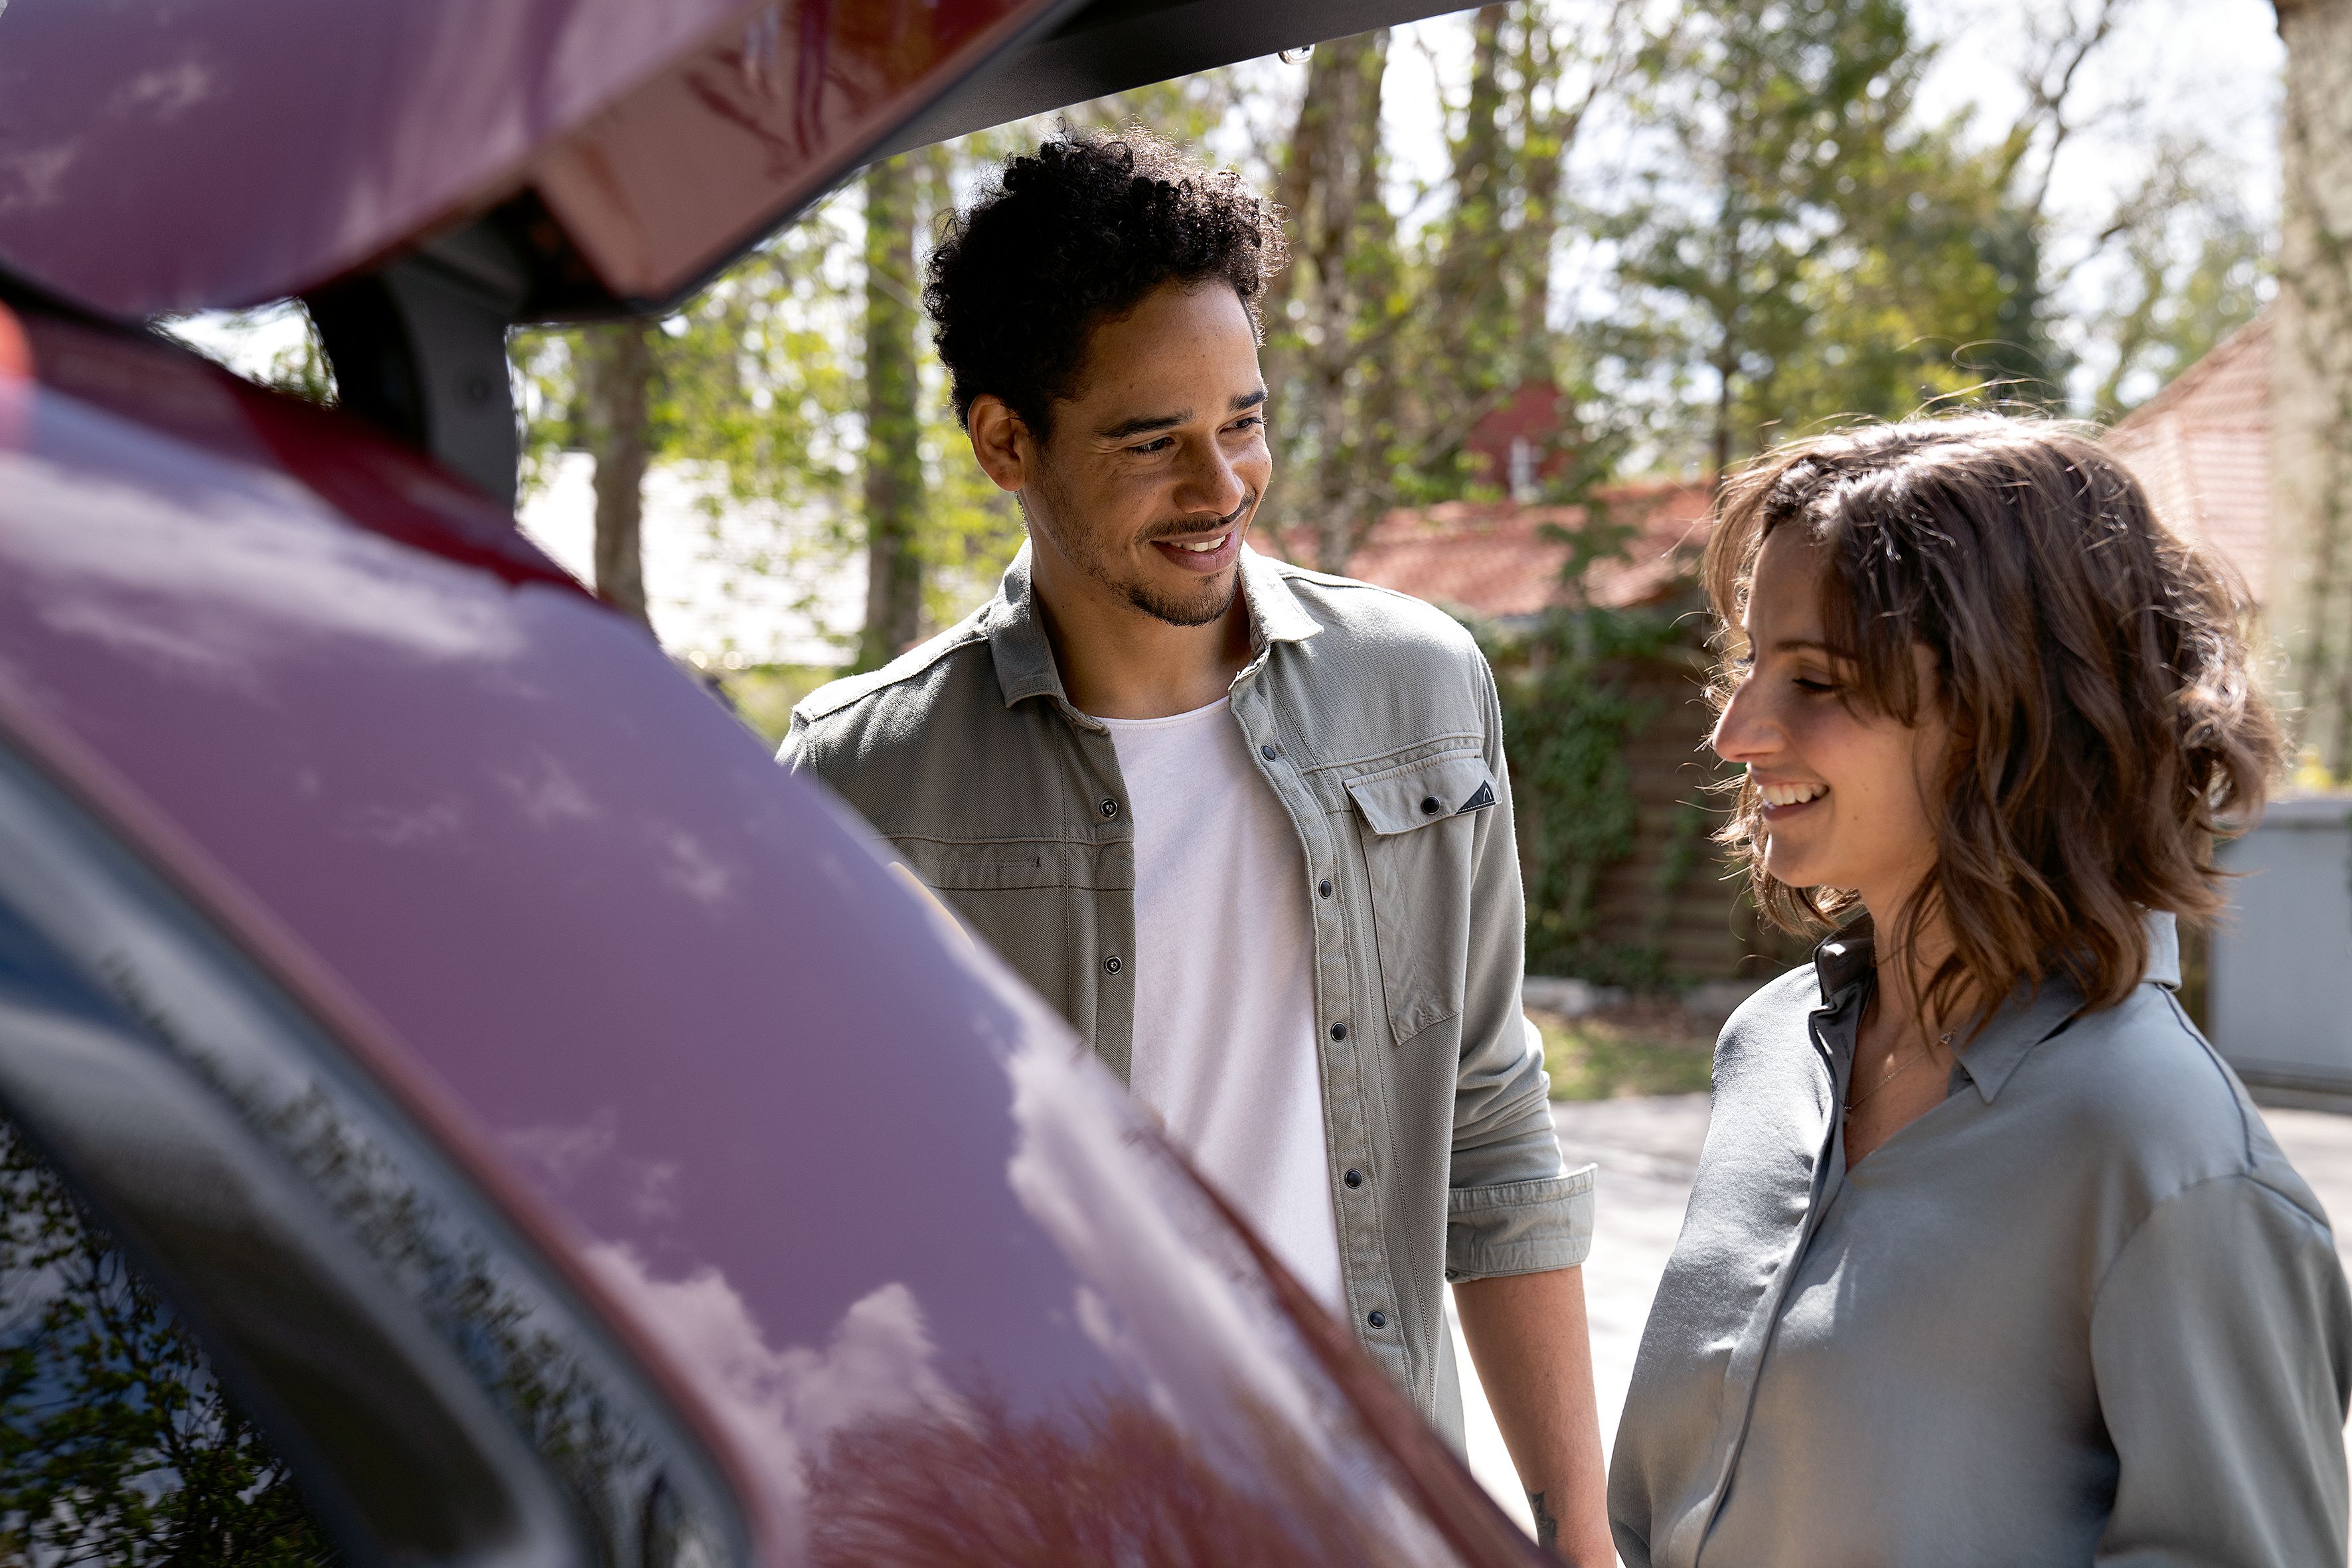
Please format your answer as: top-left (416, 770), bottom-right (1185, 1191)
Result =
top-left (1023, 284), bottom-right (1275, 625)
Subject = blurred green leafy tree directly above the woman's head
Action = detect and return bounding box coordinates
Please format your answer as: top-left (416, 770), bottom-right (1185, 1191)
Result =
top-left (1607, 0), bottom-right (2049, 470)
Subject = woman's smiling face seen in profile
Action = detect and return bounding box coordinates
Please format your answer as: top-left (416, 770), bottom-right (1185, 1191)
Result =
top-left (1715, 529), bottom-right (1950, 919)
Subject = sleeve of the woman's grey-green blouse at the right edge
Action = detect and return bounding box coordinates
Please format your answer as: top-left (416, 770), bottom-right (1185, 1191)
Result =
top-left (2091, 1176), bottom-right (2352, 1568)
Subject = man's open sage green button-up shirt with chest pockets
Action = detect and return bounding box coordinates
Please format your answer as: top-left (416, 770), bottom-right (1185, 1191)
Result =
top-left (781, 550), bottom-right (1593, 1446)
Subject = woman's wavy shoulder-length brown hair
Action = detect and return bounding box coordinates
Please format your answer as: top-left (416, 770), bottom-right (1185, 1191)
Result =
top-left (1705, 416), bottom-right (2284, 1018)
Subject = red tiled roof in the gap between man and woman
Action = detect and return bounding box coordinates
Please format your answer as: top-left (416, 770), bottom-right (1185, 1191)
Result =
top-left (1270, 479), bottom-right (1707, 621)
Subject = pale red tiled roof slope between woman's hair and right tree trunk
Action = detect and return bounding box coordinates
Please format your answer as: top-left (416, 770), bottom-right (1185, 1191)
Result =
top-left (2108, 313), bottom-right (2270, 595)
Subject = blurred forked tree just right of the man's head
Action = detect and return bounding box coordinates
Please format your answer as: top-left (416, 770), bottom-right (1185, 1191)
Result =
top-left (1265, 0), bottom-right (1637, 572)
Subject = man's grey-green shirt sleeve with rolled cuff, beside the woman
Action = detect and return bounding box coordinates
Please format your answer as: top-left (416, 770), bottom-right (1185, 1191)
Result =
top-left (1447, 658), bottom-right (1593, 1281)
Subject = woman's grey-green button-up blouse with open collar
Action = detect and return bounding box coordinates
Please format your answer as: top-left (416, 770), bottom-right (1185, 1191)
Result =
top-left (1608, 917), bottom-right (2352, 1568)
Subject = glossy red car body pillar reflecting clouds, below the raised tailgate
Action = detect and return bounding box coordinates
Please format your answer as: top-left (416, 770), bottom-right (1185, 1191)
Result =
top-left (0, 317), bottom-right (1524, 1563)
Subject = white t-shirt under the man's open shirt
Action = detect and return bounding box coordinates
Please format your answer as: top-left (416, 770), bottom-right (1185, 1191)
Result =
top-left (1103, 700), bottom-right (1346, 1309)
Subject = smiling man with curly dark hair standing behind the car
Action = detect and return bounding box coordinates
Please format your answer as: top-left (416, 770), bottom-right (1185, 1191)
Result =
top-left (783, 131), bottom-right (1613, 1563)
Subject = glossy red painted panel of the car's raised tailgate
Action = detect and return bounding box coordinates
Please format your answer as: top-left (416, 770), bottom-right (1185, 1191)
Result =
top-left (0, 0), bottom-right (1044, 320)
